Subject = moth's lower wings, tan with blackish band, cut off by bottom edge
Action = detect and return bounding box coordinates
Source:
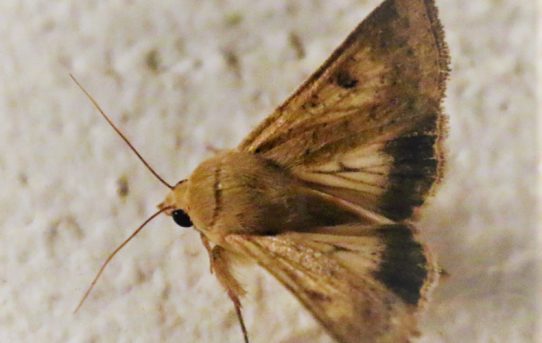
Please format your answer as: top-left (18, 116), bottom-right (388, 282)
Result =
top-left (226, 224), bottom-right (436, 343)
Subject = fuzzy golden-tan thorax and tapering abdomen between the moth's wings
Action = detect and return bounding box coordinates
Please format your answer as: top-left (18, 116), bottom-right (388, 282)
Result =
top-left (186, 151), bottom-right (359, 243)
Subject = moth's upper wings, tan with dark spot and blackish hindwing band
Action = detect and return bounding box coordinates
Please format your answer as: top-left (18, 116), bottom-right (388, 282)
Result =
top-left (239, 0), bottom-right (449, 221)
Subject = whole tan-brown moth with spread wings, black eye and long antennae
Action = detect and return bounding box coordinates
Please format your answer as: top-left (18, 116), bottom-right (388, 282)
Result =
top-left (74, 0), bottom-right (449, 343)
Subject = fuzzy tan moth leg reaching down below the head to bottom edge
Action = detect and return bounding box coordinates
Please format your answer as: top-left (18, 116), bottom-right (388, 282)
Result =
top-left (211, 243), bottom-right (249, 343)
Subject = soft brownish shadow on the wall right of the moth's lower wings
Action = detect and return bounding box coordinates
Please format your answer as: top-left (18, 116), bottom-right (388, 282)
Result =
top-left (420, 184), bottom-right (539, 342)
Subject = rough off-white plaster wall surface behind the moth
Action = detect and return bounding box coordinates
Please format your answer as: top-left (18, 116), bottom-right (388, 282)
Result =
top-left (0, 0), bottom-right (541, 343)
